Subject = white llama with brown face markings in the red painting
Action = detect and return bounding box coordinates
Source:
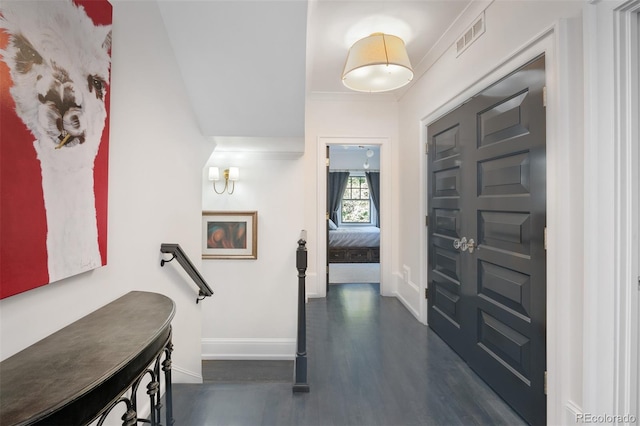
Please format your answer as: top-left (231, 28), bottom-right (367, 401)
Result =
top-left (0, 0), bottom-right (111, 282)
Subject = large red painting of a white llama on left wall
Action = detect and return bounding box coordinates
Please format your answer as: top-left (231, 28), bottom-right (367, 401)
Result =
top-left (0, 0), bottom-right (112, 298)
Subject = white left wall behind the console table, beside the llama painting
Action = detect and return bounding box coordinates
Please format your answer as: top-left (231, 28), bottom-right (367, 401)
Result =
top-left (0, 2), bottom-right (207, 382)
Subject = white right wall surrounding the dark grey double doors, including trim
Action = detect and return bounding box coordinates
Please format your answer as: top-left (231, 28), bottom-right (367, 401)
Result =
top-left (398, 0), bottom-right (583, 424)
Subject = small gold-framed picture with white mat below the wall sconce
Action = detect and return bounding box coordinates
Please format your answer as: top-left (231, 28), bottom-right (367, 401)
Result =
top-left (202, 211), bottom-right (258, 259)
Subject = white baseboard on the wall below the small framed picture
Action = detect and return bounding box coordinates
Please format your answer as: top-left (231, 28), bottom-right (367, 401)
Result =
top-left (202, 338), bottom-right (296, 360)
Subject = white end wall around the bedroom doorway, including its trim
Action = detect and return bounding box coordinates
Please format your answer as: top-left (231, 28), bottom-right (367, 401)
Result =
top-left (303, 96), bottom-right (400, 297)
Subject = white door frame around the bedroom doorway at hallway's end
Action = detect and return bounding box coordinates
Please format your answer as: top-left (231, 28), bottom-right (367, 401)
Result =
top-left (308, 136), bottom-right (394, 297)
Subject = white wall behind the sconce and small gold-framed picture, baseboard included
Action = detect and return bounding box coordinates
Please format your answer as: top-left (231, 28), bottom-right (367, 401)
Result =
top-left (201, 151), bottom-right (304, 359)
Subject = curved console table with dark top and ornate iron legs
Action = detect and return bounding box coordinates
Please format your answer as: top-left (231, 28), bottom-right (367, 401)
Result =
top-left (0, 291), bottom-right (175, 426)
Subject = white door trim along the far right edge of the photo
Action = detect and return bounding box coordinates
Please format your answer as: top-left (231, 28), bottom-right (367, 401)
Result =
top-left (583, 0), bottom-right (640, 424)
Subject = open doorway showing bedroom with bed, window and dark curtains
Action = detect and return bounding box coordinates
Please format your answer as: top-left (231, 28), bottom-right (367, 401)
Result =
top-left (327, 144), bottom-right (380, 291)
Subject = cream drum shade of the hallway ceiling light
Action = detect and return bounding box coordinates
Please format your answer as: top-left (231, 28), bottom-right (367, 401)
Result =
top-left (342, 33), bottom-right (413, 92)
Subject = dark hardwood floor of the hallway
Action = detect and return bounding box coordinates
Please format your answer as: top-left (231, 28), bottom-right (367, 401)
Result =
top-left (173, 284), bottom-right (525, 426)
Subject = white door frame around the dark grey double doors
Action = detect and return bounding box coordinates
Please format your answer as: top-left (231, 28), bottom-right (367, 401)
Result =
top-left (420, 25), bottom-right (583, 424)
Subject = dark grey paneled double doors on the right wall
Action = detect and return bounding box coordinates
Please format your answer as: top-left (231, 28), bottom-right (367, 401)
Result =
top-left (427, 57), bottom-right (546, 424)
